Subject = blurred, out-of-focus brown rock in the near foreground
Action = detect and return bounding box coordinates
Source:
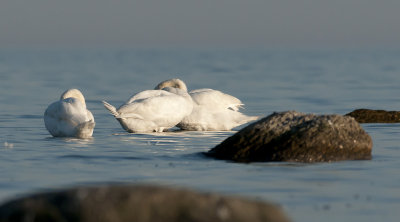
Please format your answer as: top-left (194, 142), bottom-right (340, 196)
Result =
top-left (0, 185), bottom-right (288, 222)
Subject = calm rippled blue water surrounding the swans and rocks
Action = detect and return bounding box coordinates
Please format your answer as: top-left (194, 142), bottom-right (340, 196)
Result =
top-left (0, 50), bottom-right (400, 222)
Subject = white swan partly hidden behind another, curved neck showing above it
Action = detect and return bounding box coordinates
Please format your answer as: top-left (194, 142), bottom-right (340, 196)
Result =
top-left (155, 79), bottom-right (258, 131)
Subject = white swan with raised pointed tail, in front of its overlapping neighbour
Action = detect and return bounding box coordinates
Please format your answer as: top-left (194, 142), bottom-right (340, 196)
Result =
top-left (103, 87), bottom-right (193, 133)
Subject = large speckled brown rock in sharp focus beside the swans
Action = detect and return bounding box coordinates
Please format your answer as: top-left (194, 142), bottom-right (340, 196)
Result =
top-left (206, 111), bottom-right (372, 162)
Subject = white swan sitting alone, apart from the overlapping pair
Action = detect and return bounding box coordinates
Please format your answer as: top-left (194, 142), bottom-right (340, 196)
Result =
top-left (44, 89), bottom-right (95, 138)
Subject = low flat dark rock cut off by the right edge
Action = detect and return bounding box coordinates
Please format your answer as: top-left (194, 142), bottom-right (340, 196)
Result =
top-left (346, 109), bottom-right (400, 123)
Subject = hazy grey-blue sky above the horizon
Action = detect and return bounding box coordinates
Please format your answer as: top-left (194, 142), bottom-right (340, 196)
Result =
top-left (0, 0), bottom-right (400, 48)
